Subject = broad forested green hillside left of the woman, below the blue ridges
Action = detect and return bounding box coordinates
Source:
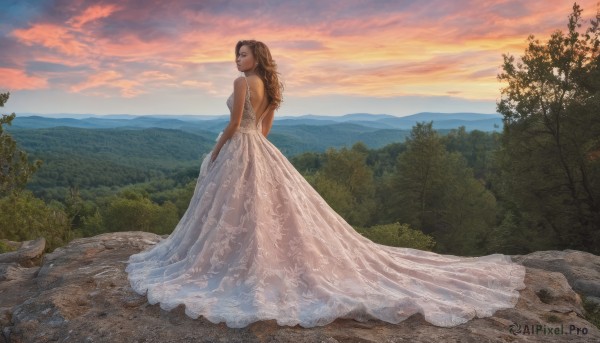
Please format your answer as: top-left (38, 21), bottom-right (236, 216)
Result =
top-left (11, 127), bottom-right (214, 199)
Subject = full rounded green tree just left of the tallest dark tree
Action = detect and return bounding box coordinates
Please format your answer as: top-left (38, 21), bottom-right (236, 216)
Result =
top-left (387, 122), bottom-right (496, 255)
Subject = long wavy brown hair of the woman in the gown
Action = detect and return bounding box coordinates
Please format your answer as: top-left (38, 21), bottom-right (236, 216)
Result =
top-left (235, 39), bottom-right (283, 109)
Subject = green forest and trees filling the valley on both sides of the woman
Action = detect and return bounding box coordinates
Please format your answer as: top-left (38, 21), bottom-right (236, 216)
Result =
top-left (0, 5), bottom-right (600, 256)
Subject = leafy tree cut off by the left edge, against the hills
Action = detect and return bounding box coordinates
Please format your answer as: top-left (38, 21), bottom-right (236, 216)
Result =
top-left (0, 93), bottom-right (42, 197)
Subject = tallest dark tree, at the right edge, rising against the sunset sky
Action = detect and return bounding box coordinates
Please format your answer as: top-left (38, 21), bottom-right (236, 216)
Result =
top-left (497, 4), bottom-right (600, 253)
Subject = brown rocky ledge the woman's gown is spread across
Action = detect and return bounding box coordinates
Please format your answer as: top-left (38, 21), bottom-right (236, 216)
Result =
top-left (0, 232), bottom-right (600, 343)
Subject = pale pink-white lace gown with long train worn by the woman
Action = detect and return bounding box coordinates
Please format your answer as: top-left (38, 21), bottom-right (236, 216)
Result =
top-left (126, 76), bottom-right (525, 328)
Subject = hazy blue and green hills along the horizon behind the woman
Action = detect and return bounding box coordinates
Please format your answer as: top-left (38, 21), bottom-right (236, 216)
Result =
top-left (6, 113), bottom-right (502, 198)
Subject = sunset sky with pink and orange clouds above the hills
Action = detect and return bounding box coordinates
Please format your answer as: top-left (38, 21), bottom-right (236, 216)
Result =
top-left (0, 0), bottom-right (598, 116)
